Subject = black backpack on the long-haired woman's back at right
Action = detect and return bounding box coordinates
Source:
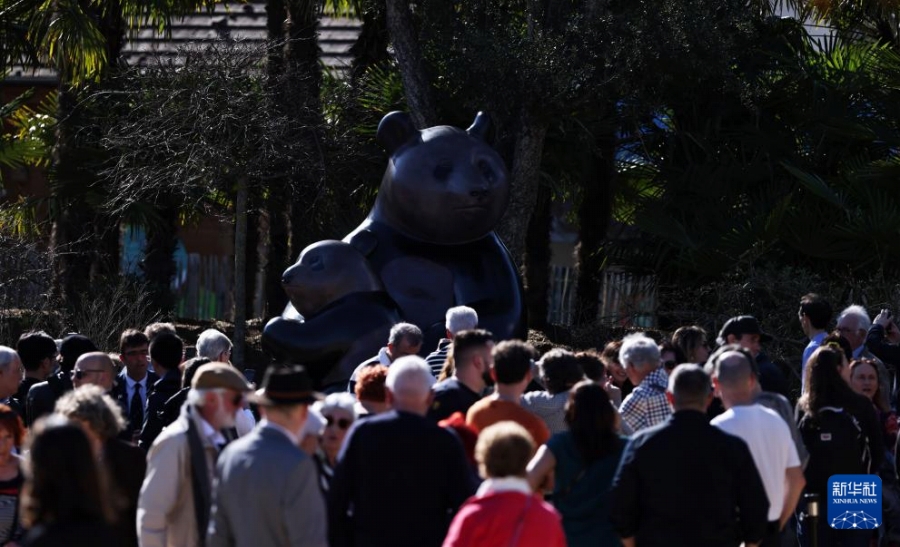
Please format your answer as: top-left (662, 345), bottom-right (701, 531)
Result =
top-left (798, 406), bottom-right (872, 494)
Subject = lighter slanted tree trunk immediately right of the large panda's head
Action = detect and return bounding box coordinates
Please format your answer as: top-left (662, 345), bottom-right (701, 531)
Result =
top-left (497, 113), bottom-right (547, 264)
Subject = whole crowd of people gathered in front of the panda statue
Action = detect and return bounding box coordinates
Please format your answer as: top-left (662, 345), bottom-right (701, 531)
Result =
top-left (0, 294), bottom-right (900, 547)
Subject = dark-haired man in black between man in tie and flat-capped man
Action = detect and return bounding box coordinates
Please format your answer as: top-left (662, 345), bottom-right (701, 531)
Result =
top-left (138, 331), bottom-right (184, 450)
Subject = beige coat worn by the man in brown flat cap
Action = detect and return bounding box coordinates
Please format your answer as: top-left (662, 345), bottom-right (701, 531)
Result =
top-left (137, 404), bottom-right (217, 547)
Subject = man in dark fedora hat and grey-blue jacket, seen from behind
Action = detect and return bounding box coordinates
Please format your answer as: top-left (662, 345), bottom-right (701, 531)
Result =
top-left (207, 365), bottom-right (328, 547)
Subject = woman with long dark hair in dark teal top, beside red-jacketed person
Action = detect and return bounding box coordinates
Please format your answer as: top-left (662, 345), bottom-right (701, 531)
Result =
top-left (528, 381), bottom-right (625, 547)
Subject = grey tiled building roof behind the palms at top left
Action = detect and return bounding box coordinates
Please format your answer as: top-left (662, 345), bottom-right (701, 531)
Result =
top-left (5, 0), bottom-right (361, 84)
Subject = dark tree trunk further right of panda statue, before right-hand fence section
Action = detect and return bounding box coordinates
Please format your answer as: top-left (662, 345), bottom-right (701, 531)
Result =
top-left (573, 133), bottom-right (616, 325)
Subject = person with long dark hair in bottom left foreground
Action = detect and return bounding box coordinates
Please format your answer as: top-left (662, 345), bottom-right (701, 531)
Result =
top-left (21, 416), bottom-right (121, 547)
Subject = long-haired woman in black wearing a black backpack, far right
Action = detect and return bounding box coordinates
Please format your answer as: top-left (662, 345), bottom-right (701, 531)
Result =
top-left (797, 342), bottom-right (885, 547)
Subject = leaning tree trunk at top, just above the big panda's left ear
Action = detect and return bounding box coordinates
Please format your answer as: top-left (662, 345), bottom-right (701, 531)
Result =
top-left (386, 0), bottom-right (437, 129)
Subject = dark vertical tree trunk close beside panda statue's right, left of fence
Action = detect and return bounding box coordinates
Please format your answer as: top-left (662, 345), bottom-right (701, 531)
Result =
top-left (525, 184), bottom-right (553, 330)
